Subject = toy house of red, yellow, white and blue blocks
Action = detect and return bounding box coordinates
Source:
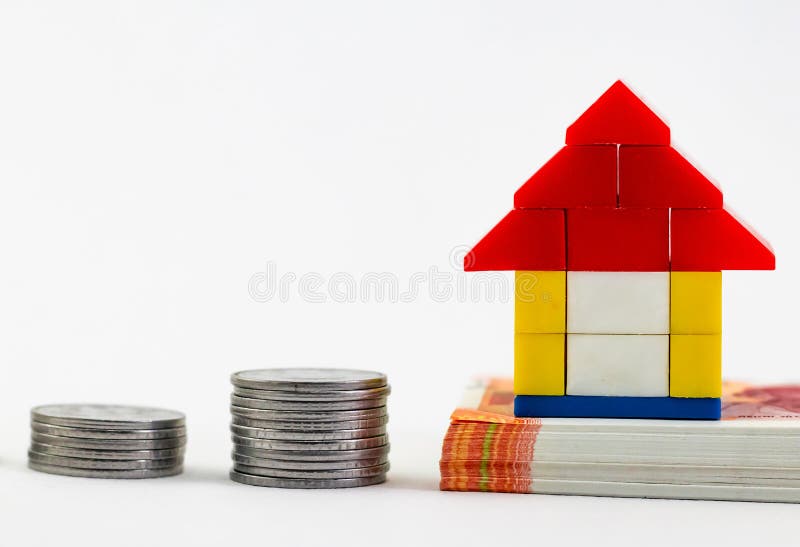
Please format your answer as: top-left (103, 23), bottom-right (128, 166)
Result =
top-left (464, 81), bottom-right (775, 419)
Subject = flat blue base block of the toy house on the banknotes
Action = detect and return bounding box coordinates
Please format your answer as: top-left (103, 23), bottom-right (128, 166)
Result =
top-left (514, 395), bottom-right (722, 420)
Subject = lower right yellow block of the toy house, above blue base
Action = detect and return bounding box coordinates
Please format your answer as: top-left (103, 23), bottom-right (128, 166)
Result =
top-left (669, 334), bottom-right (722, 397)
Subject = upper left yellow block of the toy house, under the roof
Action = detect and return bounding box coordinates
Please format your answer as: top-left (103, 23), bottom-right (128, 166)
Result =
top-left (514, 271), bottom-right (567, 334)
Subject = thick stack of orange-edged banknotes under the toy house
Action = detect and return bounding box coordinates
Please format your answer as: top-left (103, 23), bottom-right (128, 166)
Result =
top-left (440, 379), bottom-right (800, 502)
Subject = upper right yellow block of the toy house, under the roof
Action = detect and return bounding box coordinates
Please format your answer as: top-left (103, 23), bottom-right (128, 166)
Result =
top-left (670, 272), bottom-right (722, 334)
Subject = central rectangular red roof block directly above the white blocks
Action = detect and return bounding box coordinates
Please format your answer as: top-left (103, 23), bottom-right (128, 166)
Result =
top-left (564, 208), bottom-right (670, 272)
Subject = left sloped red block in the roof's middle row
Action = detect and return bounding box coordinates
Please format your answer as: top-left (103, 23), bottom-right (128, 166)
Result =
top-left (514, 145), bottom-right (617, 209)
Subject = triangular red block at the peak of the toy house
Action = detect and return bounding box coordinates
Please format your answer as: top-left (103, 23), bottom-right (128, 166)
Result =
top-left (566, 80), bottom-right (669, 145)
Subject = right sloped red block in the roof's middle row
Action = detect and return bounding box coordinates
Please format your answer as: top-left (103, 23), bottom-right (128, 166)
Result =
top-left (619, 146), bottom-right (722, 209)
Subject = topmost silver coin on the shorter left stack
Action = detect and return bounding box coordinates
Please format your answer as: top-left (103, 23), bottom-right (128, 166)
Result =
top-left (31, 404), bottom-right (186, 429)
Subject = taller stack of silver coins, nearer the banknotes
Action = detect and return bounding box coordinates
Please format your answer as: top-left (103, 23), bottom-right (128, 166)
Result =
top-left (230, 368), bottom-right (390, 488)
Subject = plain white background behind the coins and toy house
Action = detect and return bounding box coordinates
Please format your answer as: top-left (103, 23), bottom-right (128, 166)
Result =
top-left (0, 0), bottom-right (800, 547)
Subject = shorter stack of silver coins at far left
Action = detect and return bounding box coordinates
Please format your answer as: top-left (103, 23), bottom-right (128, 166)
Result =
top-left (28, 405), bottom-right (186, 479)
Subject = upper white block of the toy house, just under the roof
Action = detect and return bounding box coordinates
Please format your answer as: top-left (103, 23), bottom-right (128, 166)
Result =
top-left (567, 272), bottom-right (669, 334)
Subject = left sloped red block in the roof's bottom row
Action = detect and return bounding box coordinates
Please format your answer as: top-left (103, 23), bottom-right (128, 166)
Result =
top-left (464, 209), bottom-right (566, 272)
